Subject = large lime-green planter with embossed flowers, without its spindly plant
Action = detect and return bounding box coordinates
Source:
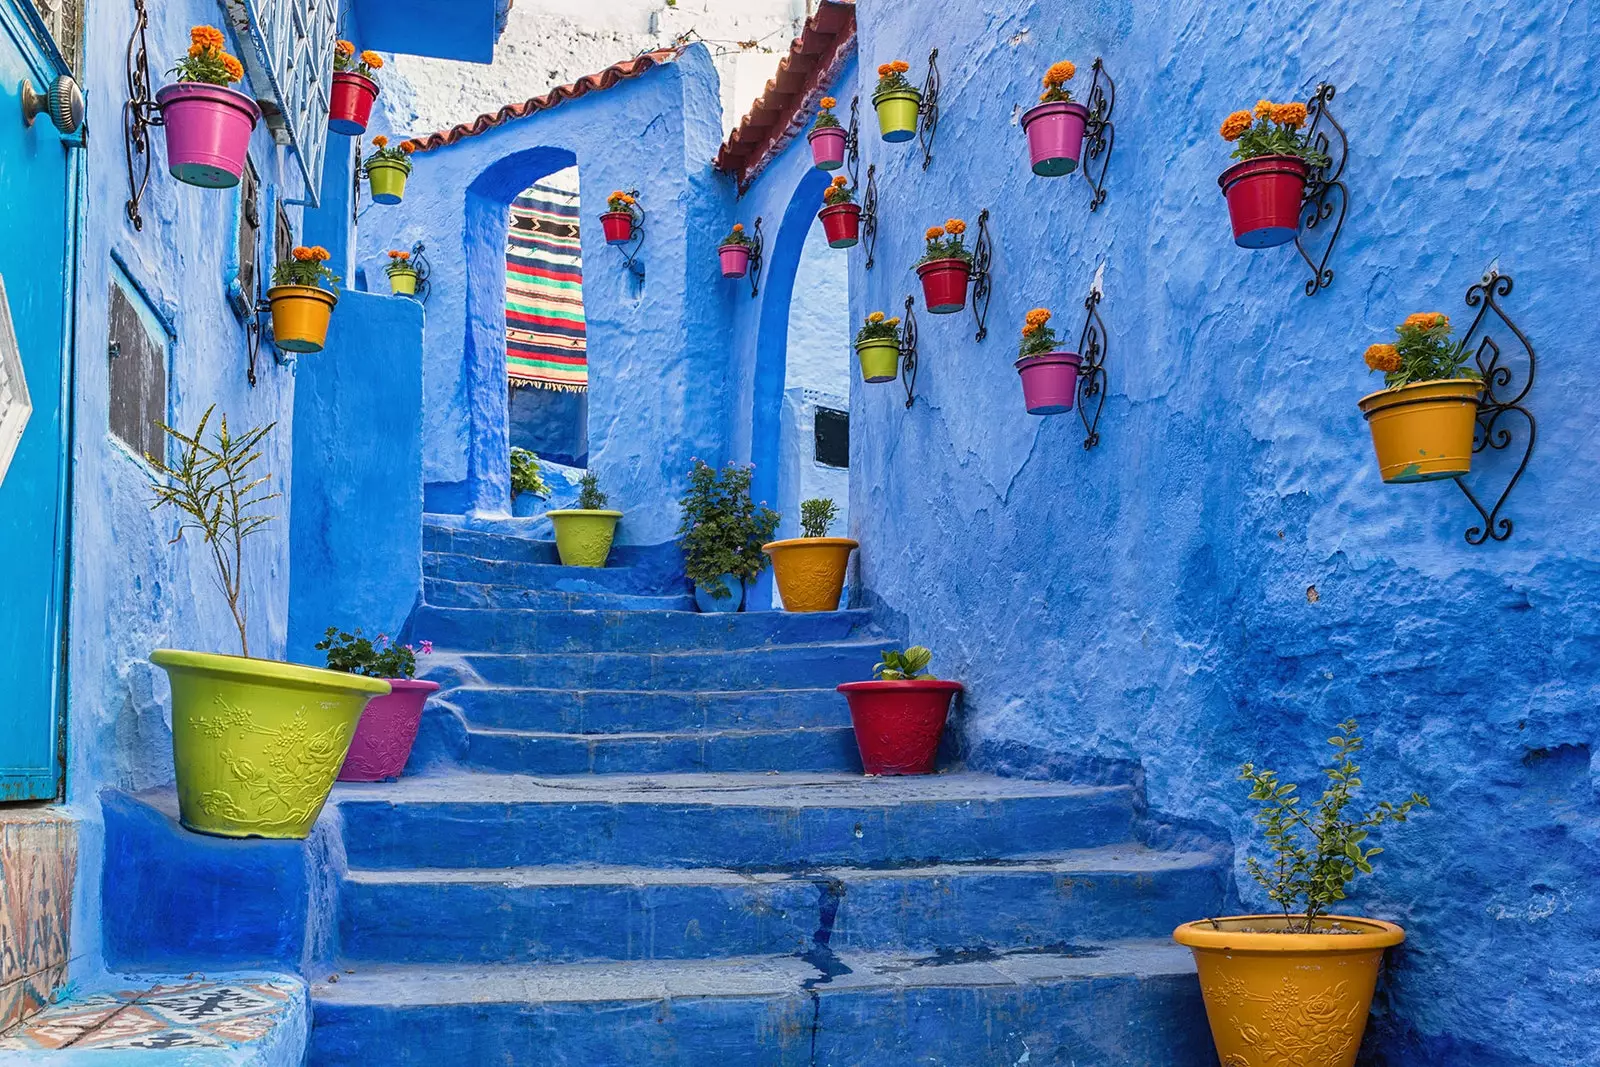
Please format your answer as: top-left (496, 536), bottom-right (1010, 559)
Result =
top-left (150, 648), bottom-right (390, 840)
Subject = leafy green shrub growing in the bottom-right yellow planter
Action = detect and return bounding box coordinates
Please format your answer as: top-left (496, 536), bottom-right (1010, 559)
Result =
top-left (1238, 718), bottom-right (1427, 933)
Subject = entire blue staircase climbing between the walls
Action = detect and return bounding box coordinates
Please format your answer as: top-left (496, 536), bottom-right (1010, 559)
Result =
top-left (310, 526), bottom-right (1229, 1067)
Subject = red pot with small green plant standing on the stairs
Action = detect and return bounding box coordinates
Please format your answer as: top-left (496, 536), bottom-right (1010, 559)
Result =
top-left (838, 645), bottom-right (962, 774)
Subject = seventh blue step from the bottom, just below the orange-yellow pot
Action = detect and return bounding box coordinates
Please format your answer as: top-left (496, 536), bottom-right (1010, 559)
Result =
top-left (411, 608), bottom-right (872, 653)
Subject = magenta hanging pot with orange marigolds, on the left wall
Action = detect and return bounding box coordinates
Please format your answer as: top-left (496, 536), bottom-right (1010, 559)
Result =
top-left (155, 26), bottom-right (261, 189)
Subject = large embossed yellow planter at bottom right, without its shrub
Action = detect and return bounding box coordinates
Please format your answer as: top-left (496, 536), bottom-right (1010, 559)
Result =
top-left (1173, 915), bottom-right (1405, 1067)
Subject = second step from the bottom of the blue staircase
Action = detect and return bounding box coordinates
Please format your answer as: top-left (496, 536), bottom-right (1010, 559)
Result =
top-left (339, 845), bottom-right (1227, 963)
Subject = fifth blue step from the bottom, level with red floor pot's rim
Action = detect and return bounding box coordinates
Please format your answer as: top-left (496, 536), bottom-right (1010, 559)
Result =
top-left (443, 686), bottom-right (850, 734)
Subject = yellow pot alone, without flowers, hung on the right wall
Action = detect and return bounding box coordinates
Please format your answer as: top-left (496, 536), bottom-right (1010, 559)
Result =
top-left (1358, 378), bottom-right (1483, 482)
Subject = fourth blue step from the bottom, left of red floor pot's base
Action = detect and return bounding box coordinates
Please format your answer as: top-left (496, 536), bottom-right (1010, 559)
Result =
top-left (466, 726), bottom-right (861, 774)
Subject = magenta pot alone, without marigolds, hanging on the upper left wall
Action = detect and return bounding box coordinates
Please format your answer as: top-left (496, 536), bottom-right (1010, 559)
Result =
top-left (155, 82), bottom-right (261, 189)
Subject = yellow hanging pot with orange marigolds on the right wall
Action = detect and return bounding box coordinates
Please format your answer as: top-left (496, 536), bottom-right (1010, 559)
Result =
top-left (1360, 312), bottom-right (1483, 482)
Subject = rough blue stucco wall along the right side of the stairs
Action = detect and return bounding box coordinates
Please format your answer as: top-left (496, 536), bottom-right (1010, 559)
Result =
top-left (734, 0), bottom-right (1600, 1067)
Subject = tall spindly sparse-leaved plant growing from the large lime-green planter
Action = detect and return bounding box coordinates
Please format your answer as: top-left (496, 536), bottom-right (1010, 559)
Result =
top-left (146, 405), bottom-right (278, 656)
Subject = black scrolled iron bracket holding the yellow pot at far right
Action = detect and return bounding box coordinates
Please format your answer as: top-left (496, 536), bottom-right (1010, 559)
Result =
top-left (1456, 267), bottom-right (1539, 544)
